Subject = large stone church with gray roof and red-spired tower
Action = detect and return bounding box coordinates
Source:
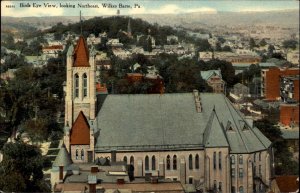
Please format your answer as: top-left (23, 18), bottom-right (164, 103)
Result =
top-left (51, 36), bottom-right (272, 193)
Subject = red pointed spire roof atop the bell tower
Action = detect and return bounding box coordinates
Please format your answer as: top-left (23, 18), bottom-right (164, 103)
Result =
top-left (73, 35), bottom-right (90, 67)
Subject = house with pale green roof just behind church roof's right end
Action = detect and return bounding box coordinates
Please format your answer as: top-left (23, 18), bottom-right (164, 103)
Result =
top-left (200, 69), bottom-right (225, 93)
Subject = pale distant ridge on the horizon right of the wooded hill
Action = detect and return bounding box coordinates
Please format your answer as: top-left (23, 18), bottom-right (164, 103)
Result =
top-left (133, 10), bottom-right (299, 28)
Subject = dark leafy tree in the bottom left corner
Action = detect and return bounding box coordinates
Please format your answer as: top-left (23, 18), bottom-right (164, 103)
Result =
top-left (0, 142), bottom-right (50, 192)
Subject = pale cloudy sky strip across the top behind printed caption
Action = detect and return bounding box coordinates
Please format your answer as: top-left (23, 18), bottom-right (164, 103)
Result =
top-left (1, 0), bottom-right (299, 17)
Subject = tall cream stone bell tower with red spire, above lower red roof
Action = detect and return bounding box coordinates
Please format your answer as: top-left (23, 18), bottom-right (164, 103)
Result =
top-left (65, 36), bottom-right (96, 126)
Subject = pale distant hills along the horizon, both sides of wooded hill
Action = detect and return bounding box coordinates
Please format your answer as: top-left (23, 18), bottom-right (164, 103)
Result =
top-left (1, 10), bottom-right (299, 34)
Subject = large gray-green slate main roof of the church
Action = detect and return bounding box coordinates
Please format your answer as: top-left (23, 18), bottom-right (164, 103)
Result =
top-left (95, 93), bottom-right (271, 153)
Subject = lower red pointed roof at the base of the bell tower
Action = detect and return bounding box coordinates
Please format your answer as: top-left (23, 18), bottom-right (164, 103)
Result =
top-left (70, 111), bottom-right (90, 145)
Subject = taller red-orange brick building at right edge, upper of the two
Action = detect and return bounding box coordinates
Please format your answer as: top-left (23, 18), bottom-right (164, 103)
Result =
top-left (261, 67), bottom-right (299, 100)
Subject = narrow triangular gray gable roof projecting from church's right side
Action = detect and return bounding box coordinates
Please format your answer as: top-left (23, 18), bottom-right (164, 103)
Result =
top-left (204, 109), bottom-right (229, 147)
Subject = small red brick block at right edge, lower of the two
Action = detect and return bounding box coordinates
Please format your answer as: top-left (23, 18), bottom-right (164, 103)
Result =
top-left (280, 103), bottom-right (299, 126)
